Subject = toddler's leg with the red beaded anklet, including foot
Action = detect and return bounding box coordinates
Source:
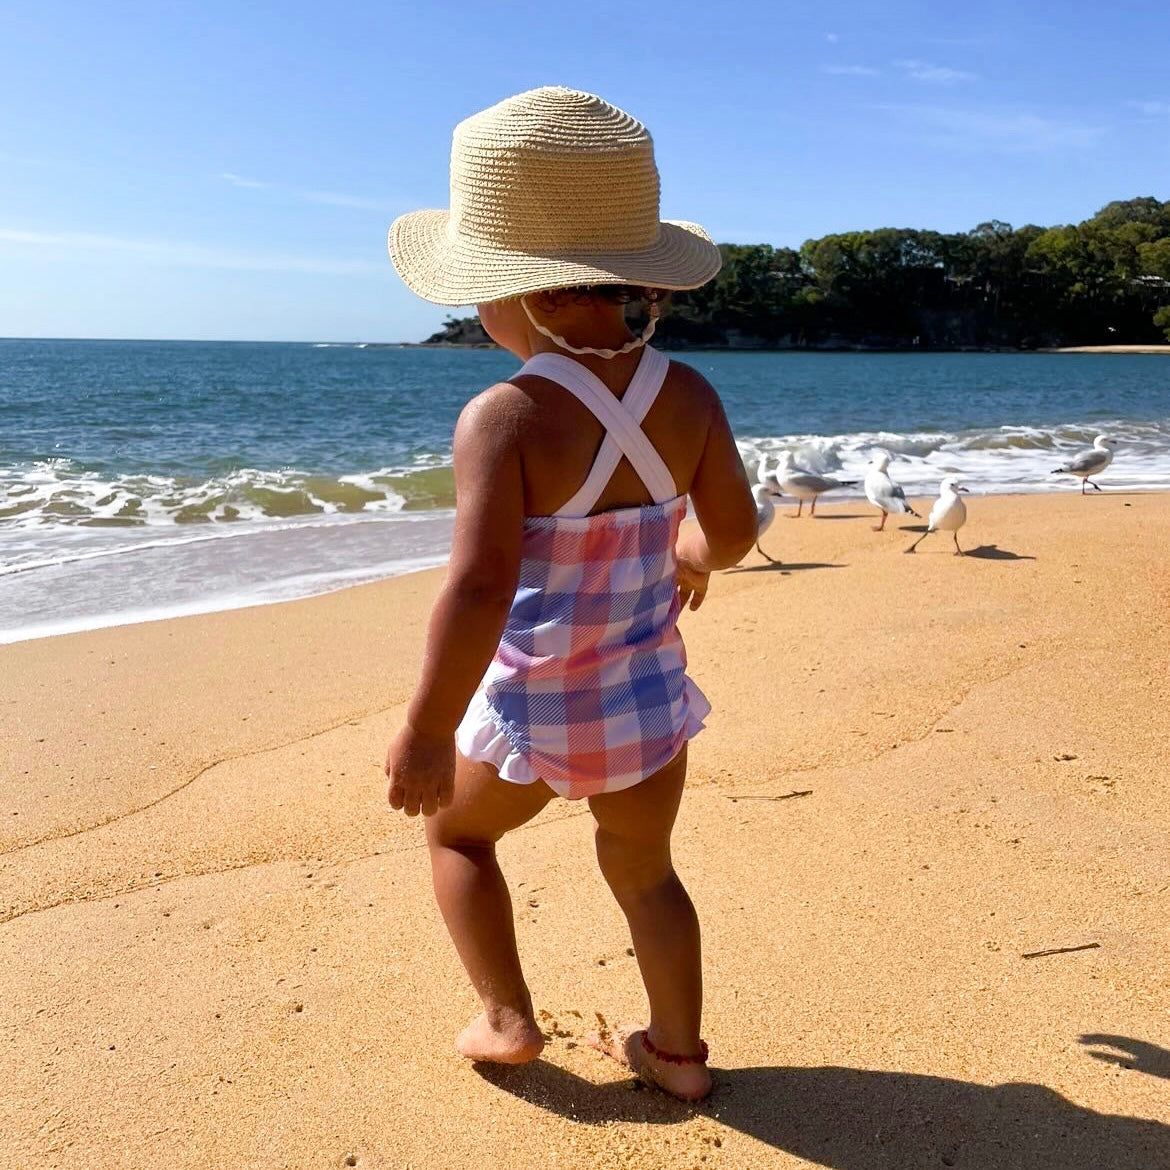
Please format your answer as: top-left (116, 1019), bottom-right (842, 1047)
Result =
top-left (590, 748), bottom-right (711, 1100)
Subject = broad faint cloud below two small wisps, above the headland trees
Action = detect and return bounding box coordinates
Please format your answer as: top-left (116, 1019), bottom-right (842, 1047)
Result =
top-left (880, 105), bottom-right (1106, 154)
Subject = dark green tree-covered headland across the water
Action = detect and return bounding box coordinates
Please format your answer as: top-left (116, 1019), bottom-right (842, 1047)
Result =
top-left (432, 198), bottom-right (1170, 350)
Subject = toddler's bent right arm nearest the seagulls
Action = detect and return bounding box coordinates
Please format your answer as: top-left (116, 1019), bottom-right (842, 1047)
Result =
top-left (676, 387), bottom-right (757, 610)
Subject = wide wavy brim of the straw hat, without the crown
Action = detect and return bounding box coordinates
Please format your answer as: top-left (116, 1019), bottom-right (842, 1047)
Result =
top-left (386, 211), bottom-right (722, 305)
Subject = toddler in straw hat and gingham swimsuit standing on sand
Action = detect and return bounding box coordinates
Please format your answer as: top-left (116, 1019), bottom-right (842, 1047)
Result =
top-left (386, 88), bottom-right (756, 1100)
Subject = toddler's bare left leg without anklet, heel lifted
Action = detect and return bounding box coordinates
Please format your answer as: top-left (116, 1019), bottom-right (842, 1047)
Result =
top-left (427, 756), bottom-right (553, 1064)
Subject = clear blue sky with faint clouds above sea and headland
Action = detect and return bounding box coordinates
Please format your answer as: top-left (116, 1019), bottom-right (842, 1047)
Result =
top-left (0, 0), bottom-right (1170, 340)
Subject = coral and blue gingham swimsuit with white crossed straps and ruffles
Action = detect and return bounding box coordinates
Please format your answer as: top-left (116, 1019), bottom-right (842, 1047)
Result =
top-left (455, 346), bottom-right (710, 799)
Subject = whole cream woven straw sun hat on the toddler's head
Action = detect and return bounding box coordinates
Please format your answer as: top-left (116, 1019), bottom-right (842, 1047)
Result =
top-left (388, 85), bottom-right (720, 305)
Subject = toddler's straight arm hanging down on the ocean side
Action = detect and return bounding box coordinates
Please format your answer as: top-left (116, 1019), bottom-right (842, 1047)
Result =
top-left (386, 391), bottom-right (524, 817)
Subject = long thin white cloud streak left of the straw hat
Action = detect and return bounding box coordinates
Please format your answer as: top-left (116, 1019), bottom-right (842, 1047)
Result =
top-left (0, 228), bottom-right (383, 276)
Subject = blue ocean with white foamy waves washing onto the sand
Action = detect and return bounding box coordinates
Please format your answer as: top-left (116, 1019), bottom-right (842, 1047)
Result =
top-left (0, 339), bottom-right (1170, 642)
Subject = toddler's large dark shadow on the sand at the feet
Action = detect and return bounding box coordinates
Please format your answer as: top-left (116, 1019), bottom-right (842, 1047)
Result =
top-left (476, 1057), bottom-right (1170, 1170)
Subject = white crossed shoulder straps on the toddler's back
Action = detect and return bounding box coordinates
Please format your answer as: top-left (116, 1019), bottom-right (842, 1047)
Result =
top-left (521, 346), bottom-right (677, 517)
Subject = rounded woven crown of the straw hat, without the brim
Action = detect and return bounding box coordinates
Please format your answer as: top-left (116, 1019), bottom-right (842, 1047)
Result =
top-left (447, 85), bottom-right (659, 256)
